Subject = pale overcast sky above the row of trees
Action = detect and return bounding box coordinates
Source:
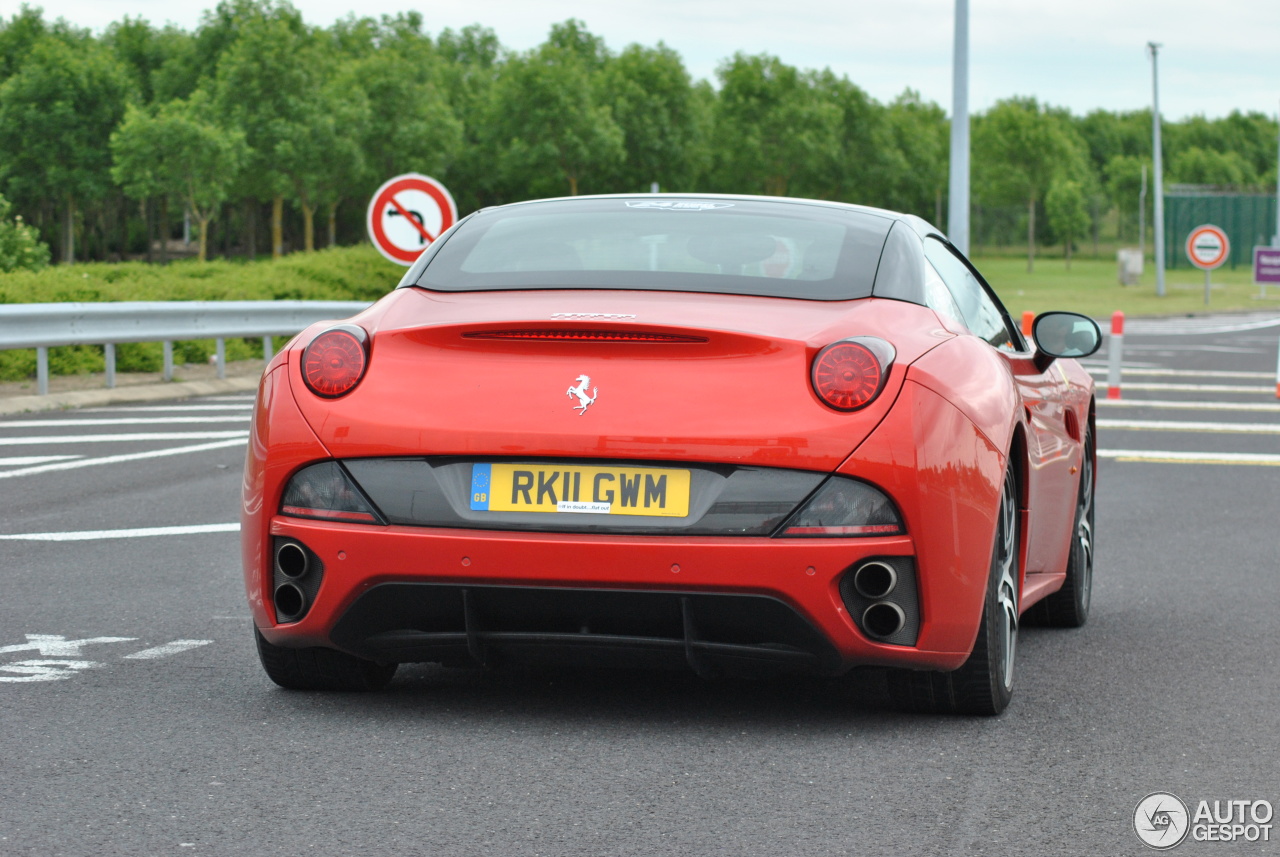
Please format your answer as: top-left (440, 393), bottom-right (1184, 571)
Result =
top-left (17, 0), bottom-right (1280, 119)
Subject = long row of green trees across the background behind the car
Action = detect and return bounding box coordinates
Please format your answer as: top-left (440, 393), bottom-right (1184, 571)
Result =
top-left (0, 0), bottom-right (1277, 270)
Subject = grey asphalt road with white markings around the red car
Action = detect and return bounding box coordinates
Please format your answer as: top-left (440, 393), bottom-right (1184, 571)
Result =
top-left (0, 322), bottom-right (1280, 857)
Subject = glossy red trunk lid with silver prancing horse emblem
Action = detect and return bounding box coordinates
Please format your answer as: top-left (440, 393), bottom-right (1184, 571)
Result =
top-left (294, 289), bottom-right (947, 471)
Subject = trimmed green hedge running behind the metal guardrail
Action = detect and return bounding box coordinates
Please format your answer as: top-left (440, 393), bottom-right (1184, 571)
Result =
top-left (0, 244), bottom-right (404, 381)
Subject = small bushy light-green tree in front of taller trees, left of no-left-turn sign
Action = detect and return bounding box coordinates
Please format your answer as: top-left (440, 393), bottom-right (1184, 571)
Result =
top-left (111, 92), bottom-right (246, 262)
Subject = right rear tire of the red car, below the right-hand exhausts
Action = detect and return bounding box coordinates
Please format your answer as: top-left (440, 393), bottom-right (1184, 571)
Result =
top-left (888, 466), bottom-right (1020, 715)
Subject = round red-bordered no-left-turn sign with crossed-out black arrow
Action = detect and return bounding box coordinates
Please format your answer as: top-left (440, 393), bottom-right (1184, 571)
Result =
top-left (366, 173), bottom-right (458, 265)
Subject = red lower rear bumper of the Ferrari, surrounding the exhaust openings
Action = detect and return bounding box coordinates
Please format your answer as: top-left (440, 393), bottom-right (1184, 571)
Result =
top-left (250, 515), bottom-right (972, 675)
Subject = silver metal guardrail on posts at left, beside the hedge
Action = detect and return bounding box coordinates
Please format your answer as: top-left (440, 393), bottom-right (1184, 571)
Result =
top-left (0, 301), bottom-right (369, 395)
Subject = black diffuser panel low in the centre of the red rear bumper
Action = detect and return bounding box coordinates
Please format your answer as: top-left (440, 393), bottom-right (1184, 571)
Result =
top-left (332, 583), bottom-right (840, 674)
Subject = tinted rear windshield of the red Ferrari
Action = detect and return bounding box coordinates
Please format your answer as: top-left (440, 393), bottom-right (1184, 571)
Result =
top-left (413, 197), bottom-right (892, 301)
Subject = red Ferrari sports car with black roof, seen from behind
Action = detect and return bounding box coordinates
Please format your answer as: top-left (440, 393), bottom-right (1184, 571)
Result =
top-left (242, 194), bottom-right (1101, 714)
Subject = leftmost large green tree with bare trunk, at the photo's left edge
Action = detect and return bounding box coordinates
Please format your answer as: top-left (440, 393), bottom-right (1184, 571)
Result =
top-left (0, 36), bottom-right (133, 262)
